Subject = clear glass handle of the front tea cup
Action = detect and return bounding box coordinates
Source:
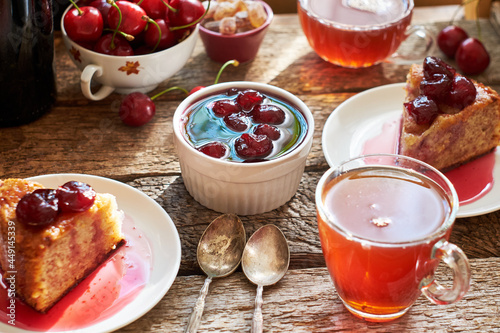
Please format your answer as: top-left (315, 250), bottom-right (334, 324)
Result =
top-left (420, 239), bottom-right (471, 304)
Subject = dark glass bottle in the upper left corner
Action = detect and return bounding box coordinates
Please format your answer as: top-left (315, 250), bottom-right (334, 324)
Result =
top-left (0, 0), bottom-right (56, 127)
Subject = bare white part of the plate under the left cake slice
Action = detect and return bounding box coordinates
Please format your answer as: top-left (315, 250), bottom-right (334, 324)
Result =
top-left (0, 174), bottom-right (181, 333)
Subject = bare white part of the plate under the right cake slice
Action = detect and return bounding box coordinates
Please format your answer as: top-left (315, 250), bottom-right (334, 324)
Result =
top-left (321, 83), bottom-right (500, 217)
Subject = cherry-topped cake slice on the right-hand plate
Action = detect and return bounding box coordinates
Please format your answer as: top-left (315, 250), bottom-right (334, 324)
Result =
top-left (398, 57), bottom-right (500, 171)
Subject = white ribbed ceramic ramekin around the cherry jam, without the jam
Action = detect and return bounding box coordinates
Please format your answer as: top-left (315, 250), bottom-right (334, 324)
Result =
top-left (173, 82), bottom-right (314, 215)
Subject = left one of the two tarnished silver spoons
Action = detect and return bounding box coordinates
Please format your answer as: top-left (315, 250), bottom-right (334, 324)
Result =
top-left (185, 214), bottom-right (246, 333)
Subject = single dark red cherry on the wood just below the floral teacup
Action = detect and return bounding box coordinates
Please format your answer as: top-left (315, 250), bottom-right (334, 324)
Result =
top-left (118, 92), bottom-right (156, 127)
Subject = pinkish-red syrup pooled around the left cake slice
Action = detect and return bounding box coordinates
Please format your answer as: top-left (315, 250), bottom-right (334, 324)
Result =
top-left (0, 216), bottom-right (152, 332)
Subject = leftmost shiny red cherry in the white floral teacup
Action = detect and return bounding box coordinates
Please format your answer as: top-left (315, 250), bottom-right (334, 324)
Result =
top-left (63, 5), bottom-right (103, 42)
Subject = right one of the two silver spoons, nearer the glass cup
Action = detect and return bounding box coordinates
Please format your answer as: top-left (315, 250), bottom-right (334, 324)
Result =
top-left (241, 224), bottom-right (290, 333)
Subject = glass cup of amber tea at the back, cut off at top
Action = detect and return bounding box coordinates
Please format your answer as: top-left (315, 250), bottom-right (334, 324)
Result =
top-left (298, 0), bottom-right (434, 68)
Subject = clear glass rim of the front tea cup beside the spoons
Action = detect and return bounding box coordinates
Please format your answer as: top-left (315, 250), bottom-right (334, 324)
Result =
top-left (315, 154), bottom-right (459, 247)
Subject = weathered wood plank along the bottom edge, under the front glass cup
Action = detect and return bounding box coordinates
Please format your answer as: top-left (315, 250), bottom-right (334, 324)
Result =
top-left (118, 258), bottom-right (500, 333)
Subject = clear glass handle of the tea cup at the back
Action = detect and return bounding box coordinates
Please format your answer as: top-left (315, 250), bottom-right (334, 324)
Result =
top-left (389, 25), bottom-right (436, 64)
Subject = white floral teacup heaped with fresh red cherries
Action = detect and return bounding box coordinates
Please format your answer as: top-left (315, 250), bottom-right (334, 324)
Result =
top-left (61, 0), bottom-right (205, 100)
